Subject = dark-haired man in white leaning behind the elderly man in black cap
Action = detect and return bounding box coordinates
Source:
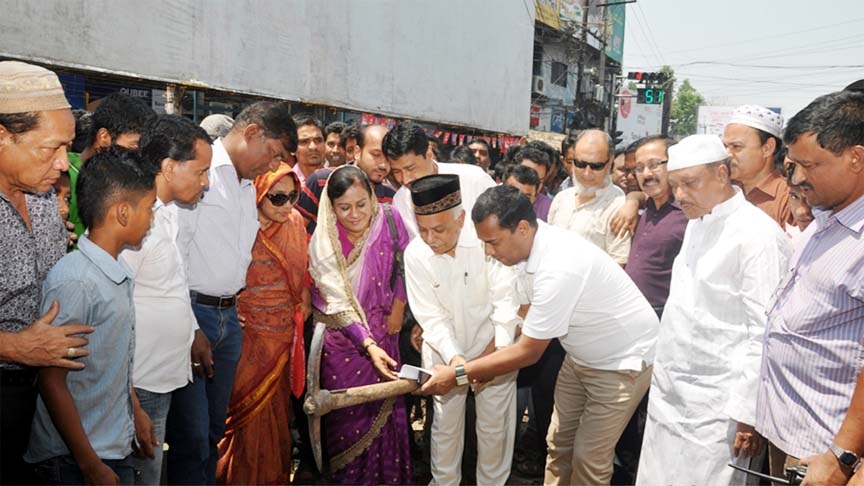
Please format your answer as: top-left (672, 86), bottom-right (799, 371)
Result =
top-left (382, 121), bottom-right (495, 238)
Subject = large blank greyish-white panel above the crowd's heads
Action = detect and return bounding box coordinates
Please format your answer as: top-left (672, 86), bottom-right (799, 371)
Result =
top-left (0, 0), bottom-right (534, 134)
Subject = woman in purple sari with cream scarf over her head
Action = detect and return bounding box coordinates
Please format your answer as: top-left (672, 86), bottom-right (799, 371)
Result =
top-left (309, 166), bottom-right (411, 485)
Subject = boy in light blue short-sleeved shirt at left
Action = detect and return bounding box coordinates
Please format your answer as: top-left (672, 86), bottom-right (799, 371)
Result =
top-left (24, 148), bottom-right (156, 484)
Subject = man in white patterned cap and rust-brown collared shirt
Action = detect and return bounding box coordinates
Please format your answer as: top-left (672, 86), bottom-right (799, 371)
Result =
top-left (723, 105), bottom-right (793, 228)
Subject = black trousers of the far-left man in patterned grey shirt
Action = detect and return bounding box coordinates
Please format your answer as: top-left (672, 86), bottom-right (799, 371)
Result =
top-left (0, 369), bottom-right (37, 484)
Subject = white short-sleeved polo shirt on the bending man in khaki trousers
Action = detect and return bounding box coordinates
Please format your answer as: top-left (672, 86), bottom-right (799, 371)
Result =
top-left (519, 221), bottom-right (659, 371)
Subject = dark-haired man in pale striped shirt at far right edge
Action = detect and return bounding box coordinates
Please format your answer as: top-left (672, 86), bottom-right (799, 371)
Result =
top-left (756, 91), bottom-right (864, 484)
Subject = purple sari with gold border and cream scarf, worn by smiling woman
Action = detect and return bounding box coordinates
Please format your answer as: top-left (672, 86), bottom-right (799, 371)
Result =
top-left (310, 199), bottom-right (412, 485)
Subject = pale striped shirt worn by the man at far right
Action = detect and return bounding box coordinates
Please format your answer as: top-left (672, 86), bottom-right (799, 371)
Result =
top-left (756, 197), bottom-right (864, 457)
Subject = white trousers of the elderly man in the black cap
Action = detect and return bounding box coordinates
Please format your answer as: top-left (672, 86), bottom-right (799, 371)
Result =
top-left (429, 372), bottom-right (516, 486)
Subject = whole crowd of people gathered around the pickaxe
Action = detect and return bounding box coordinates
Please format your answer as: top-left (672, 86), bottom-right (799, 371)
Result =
top-left (0, 61), bottom-right (864, 485)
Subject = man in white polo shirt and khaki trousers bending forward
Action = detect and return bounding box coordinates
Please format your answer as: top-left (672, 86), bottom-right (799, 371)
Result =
top-left (421, 186), bottom-right (658, 485)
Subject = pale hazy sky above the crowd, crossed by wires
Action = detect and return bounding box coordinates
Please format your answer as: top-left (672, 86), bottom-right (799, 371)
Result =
top-left (623, 0), bottom-right (864, 118)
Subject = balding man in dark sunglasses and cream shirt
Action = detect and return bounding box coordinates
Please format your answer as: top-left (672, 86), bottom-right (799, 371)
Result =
top-left (548, 130), bottom-right (630, 267)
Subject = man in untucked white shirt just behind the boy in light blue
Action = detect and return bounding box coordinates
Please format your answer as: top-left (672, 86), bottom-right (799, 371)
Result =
top-left (120, 115), bottom-right (213, 485)
